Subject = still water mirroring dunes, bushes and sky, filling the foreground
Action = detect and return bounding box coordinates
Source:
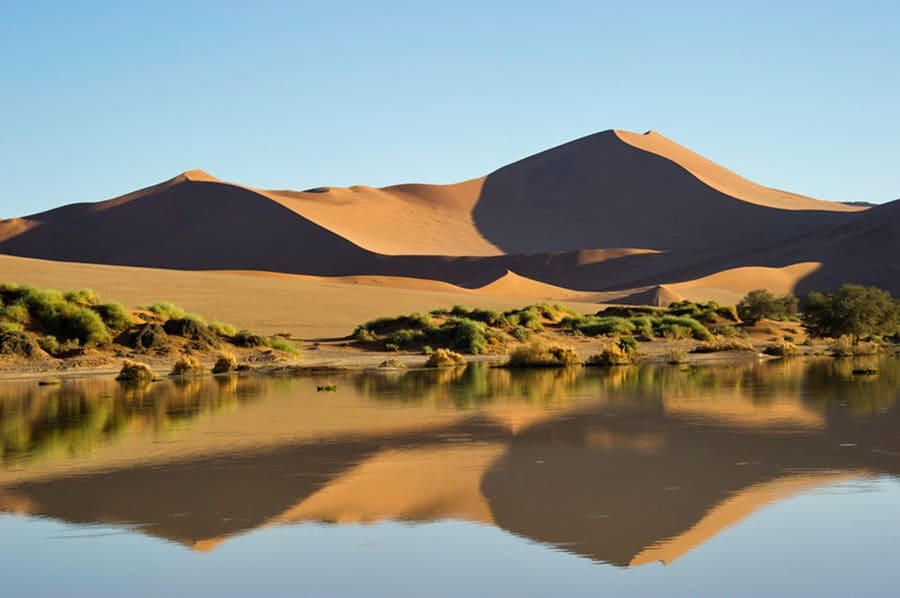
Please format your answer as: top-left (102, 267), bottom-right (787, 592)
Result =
top-left (0, 358), bottom-right (900, 596)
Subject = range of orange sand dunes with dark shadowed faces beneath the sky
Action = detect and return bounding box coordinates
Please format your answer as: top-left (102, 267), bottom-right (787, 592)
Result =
top-left (0, 131), bottom-right (900, 304)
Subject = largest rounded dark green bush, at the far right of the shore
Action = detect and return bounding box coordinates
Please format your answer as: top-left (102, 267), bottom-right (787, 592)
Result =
top-left (803, 284), bottom-right (900, 344)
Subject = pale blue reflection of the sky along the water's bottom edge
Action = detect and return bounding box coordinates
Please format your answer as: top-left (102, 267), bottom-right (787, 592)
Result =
top-left (0, 477), bottom-right (900, 596)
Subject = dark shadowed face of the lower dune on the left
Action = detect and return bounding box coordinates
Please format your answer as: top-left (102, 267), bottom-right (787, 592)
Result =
top-left (3, 180), bottom-right (370, 274)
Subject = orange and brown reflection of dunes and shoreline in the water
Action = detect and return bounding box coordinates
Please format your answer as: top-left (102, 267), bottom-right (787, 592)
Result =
top-left (0, 361), bottom-right (900, 566)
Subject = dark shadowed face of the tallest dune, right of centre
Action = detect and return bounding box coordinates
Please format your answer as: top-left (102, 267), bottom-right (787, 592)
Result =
top-left (475, 131), bottom-right (846, 253)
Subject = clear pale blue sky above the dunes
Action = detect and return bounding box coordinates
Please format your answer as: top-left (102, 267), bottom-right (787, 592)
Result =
top-left (0, 0), bottom-right (900, 217)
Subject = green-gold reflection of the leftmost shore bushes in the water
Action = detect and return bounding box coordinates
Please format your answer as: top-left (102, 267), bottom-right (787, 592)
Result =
top-left (0, 378), bottom-right (268, 467)
